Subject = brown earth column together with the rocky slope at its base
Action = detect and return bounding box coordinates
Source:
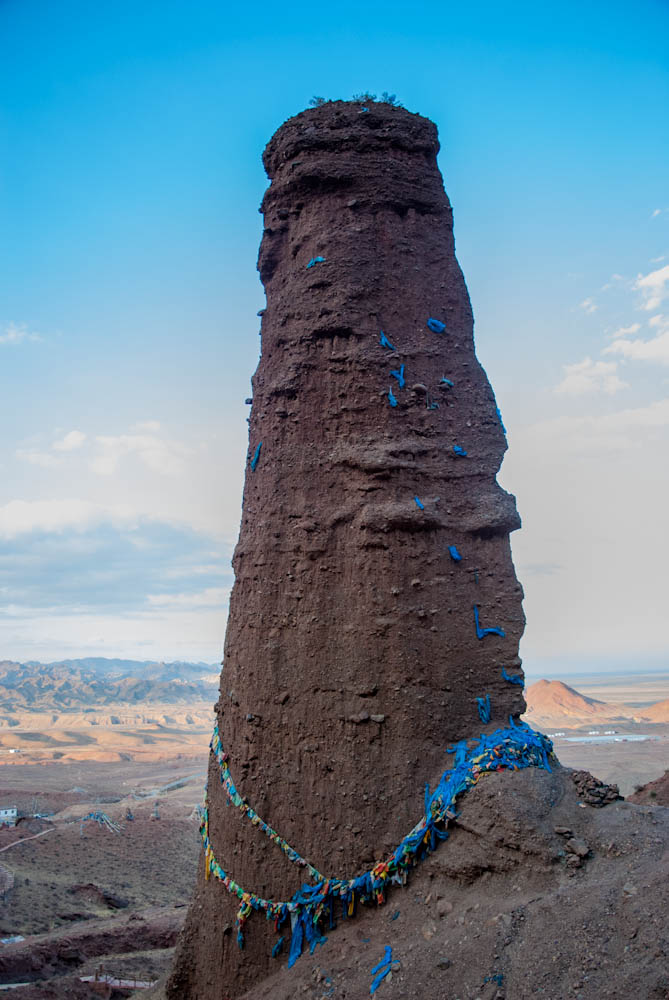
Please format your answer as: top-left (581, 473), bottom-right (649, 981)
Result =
top-left (164, 103), bottom-right (669, 1000)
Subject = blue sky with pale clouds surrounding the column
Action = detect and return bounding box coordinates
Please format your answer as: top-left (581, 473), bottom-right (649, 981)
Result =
top-left (0, 0), bottom-right (669, 676)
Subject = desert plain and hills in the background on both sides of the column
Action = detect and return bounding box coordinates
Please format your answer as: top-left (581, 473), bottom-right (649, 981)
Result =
top-left (0, 662), bottom-right (669, 998)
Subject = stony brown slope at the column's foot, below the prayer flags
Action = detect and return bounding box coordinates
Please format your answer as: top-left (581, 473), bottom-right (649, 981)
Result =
top-left (154, 768), bottom-right (669, 1000)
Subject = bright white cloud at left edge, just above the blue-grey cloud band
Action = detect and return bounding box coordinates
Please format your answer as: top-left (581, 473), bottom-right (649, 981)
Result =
top-left (0, 499), bottom-right (135, 538)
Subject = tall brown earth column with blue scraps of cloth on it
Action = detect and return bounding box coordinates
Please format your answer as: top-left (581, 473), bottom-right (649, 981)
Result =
top-left (168, 102), bottom-right (524, 1000)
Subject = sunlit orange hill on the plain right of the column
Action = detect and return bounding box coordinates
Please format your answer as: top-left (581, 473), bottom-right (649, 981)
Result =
top-left (524, 681), bottom-right (669, 727)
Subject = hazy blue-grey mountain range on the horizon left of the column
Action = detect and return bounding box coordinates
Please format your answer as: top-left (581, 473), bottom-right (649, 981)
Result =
top-left (0, 658), bottom-right (220, 715)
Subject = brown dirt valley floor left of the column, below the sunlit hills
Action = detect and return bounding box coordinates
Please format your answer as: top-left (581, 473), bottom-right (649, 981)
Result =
top-left (0, 748), bottom-right (208, 1000)
